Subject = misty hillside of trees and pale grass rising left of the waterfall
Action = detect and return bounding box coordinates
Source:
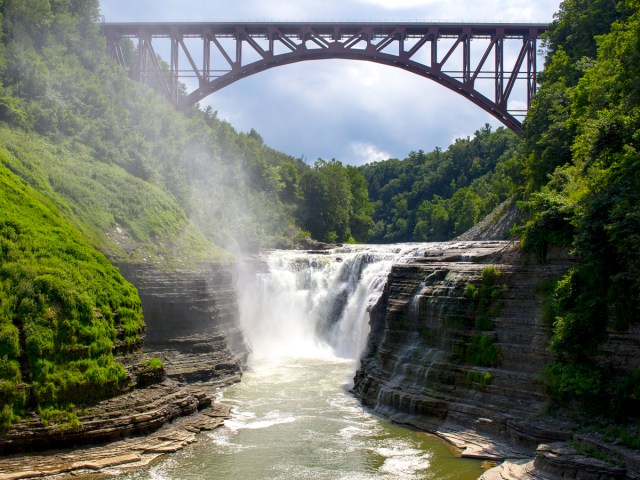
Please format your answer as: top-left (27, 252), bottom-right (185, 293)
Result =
top-left (0, 0), bottom-right (318, 255)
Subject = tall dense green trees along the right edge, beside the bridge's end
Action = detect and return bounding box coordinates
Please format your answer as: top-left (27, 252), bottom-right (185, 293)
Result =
top-left (522, 0), bottom-right (640, 418)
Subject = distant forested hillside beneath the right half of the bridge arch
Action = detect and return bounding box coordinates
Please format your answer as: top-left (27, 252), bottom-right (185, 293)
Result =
top-left (361, 125), bottom-right (522, 243)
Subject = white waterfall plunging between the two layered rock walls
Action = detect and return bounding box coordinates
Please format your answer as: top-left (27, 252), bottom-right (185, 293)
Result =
top-left (237, 245), bottom-right (419, 362)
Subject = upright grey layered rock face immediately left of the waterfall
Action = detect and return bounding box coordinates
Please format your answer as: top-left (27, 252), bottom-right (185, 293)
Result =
top-left (119, 264), bottom-right (249, 376)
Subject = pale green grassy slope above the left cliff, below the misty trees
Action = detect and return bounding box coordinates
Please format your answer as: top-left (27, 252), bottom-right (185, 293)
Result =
top-left (0, 125), bottom-right (229, 266)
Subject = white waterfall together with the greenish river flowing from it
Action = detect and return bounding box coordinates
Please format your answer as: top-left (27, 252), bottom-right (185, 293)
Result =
top-left (117, 246), bottom-right (483, 480)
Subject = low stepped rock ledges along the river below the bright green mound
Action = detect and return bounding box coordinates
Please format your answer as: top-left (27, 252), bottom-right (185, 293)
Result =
top-left (0, 335), bottom-right (242, 480)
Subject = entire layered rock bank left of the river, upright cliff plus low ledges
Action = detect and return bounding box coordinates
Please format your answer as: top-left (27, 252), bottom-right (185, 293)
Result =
top-left (0, 264), bottom-right (248, 479)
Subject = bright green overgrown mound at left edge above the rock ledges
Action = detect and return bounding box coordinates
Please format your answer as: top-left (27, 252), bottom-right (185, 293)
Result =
top-left (0, 160), bottom-right (144, 428)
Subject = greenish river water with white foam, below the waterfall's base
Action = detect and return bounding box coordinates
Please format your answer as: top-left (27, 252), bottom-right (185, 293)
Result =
top-left (118, 358), bottom-right (483, 480)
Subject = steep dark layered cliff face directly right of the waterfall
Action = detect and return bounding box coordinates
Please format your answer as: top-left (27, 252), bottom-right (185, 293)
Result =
top-left (354, 242), bottom-right (568, 447)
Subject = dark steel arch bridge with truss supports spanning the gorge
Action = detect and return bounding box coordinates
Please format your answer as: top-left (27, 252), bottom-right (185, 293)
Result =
top-left (101, 22), bottom-right (548, 131)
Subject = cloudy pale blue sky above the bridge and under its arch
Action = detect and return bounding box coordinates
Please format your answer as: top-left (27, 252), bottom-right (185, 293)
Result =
top-left (100, 0), bottom-right (560, 165)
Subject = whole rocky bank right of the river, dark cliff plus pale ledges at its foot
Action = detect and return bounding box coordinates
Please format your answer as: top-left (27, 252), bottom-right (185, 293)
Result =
top-left (353, 241), bottom-right (640, 480)
